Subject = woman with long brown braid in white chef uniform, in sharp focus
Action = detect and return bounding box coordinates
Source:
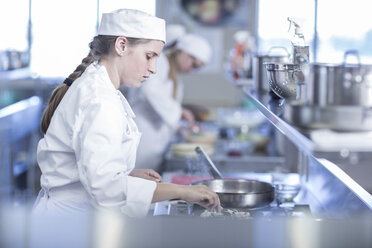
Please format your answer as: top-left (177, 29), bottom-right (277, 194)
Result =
top-left (33, 9), bottom-right (221, 217)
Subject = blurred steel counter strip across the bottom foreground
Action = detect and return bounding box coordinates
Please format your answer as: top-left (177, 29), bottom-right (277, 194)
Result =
top-left (0, 205), bottom-right (372, 248)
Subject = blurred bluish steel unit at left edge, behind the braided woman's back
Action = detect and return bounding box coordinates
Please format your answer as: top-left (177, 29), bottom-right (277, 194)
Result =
top-left (0, 96), bottom-right (42, 201)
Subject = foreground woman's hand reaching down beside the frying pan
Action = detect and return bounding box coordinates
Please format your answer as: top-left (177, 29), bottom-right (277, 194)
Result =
top-left (182, 185), bottom-right (222, 212)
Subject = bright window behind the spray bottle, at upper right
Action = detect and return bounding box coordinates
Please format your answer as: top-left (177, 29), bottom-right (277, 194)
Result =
top-left (258, 0), bottom-right (372, 64)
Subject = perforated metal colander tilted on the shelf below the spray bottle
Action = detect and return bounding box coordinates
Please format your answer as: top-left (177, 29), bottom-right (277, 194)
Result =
top-left (264, 63), bottom-right (303, 99)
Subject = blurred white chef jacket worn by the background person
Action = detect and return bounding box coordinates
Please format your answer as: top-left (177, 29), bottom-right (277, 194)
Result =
top-left (128, 54), bottom-right (183, 170)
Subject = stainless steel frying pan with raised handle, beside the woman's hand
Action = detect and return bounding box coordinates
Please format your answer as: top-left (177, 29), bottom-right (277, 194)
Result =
top-left (191, 146), bottom-right (275, 208)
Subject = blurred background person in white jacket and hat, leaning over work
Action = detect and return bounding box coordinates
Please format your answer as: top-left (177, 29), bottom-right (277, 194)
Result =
top-left (128, 30), bottom-right (211, 172)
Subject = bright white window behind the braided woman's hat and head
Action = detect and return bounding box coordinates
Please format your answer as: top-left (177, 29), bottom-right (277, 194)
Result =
top-left (29, 0), bottom-right (155, 77)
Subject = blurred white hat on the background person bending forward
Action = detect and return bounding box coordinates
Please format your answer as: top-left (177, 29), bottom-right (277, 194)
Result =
top-left (176, 34), bottom-right (212, 63)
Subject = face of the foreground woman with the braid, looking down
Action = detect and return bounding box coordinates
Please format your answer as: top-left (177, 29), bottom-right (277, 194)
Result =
top-left (120, 40), bottom-right (164, 88)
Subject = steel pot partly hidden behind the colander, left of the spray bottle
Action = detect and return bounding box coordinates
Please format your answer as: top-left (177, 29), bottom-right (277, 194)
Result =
top-left (252, 47), bottom-right (290, 93)
